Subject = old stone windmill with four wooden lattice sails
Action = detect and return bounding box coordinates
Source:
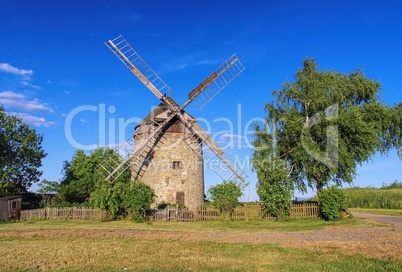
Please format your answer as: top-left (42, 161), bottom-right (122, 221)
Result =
top-left (100, 35), bottom-right (247, 209)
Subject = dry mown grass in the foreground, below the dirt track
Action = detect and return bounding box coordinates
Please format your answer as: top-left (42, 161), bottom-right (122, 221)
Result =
top-left (0, 233), bottom-right (402, 271)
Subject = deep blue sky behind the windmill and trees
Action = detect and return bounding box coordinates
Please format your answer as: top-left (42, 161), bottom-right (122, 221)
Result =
top-left (0, 0), bottom-right (402, 200)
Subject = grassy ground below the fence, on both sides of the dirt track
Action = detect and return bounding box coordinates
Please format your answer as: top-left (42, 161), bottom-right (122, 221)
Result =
top-left (0, 218), bottom-right (402, 271)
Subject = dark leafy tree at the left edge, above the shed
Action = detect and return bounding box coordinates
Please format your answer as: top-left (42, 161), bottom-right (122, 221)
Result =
top-left (0, 106), bottom-right (46, 195)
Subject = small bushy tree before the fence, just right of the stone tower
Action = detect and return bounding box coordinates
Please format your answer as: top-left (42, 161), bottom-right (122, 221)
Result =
top-left (208, 180), bottom-right (245, 216)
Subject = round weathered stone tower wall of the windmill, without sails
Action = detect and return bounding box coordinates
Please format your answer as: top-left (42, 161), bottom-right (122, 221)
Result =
top-left (135, 122), bottom-right (204, 210)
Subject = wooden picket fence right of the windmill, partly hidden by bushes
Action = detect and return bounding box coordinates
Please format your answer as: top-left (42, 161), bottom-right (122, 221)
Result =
top-left (152, 202), bottom-right (319, 221)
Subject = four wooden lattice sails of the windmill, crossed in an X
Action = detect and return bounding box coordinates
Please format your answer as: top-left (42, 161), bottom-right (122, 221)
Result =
top-left (101, 35), bottom-right (247, 206)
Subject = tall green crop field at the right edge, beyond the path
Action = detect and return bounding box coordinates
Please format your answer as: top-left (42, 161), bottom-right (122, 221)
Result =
top-left (344, 188), bottom-right (402, 209)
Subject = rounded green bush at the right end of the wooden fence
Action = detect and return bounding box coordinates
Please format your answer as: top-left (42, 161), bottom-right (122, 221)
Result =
top-left (318, 186), bottom-right (346, 221)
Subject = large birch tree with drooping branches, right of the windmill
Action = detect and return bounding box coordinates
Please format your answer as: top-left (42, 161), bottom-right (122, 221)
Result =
top-left (255, 58), bottom-right (401, 200)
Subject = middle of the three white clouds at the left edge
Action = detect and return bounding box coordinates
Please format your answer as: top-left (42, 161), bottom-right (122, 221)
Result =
top-left (0, 91), bottom-right (53, 112)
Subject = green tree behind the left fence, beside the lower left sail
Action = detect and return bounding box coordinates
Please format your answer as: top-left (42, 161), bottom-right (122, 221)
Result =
top-left (59, 147), bottom-right (126, 204)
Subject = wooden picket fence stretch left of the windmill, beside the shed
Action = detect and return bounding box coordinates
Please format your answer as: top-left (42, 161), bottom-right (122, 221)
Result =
top-left (20, 207), bottom-right (106, 220)
